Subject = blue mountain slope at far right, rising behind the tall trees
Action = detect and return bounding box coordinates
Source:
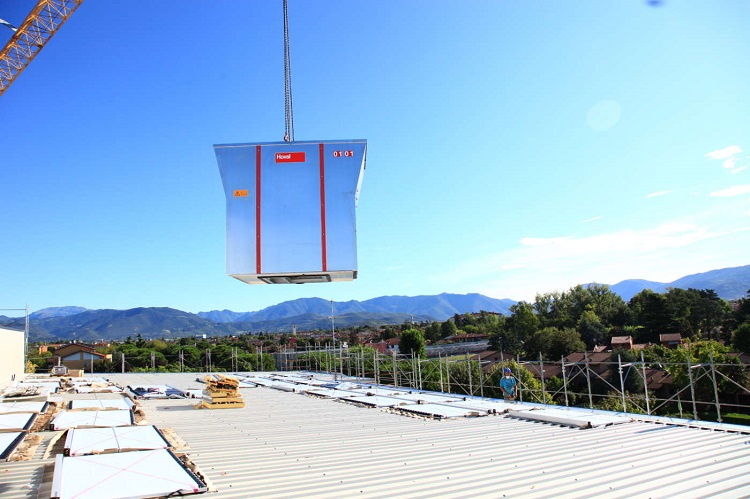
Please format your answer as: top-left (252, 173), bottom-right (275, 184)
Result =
top-left (610, 265), bottom-right (750, 301)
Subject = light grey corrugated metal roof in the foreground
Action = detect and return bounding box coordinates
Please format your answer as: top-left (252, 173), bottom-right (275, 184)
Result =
top-left (0, 373), bottom-right (750, 499)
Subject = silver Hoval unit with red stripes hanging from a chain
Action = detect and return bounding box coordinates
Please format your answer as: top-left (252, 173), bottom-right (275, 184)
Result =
top-left (214, 140), bottom-right (367, 284)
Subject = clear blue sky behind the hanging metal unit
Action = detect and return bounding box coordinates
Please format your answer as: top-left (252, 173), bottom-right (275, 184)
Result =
top-left (0, 0), bottom-right (750, 312)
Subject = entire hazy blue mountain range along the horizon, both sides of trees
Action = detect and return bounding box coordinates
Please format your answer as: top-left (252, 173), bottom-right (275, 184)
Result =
top-left (0, 265), bottom-right (750, 341)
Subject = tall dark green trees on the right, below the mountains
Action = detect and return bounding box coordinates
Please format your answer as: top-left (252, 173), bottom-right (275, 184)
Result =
top-left (401, 284), bottom-right (750, 360)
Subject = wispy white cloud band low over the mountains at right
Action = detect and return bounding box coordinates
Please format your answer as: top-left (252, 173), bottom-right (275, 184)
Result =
top-left (432, 223), bottom-right (750, 300)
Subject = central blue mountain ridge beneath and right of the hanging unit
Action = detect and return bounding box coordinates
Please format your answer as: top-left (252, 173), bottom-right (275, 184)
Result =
top-left (198, 293), bottom-right (516, 323)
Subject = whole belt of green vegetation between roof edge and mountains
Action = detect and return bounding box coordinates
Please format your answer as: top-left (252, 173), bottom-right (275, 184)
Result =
top-left (27, 285), bottom-right (750, 419)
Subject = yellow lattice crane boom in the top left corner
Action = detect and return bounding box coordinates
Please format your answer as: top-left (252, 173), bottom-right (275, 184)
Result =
top-left (0, 0), bottom-right (83, 95)
